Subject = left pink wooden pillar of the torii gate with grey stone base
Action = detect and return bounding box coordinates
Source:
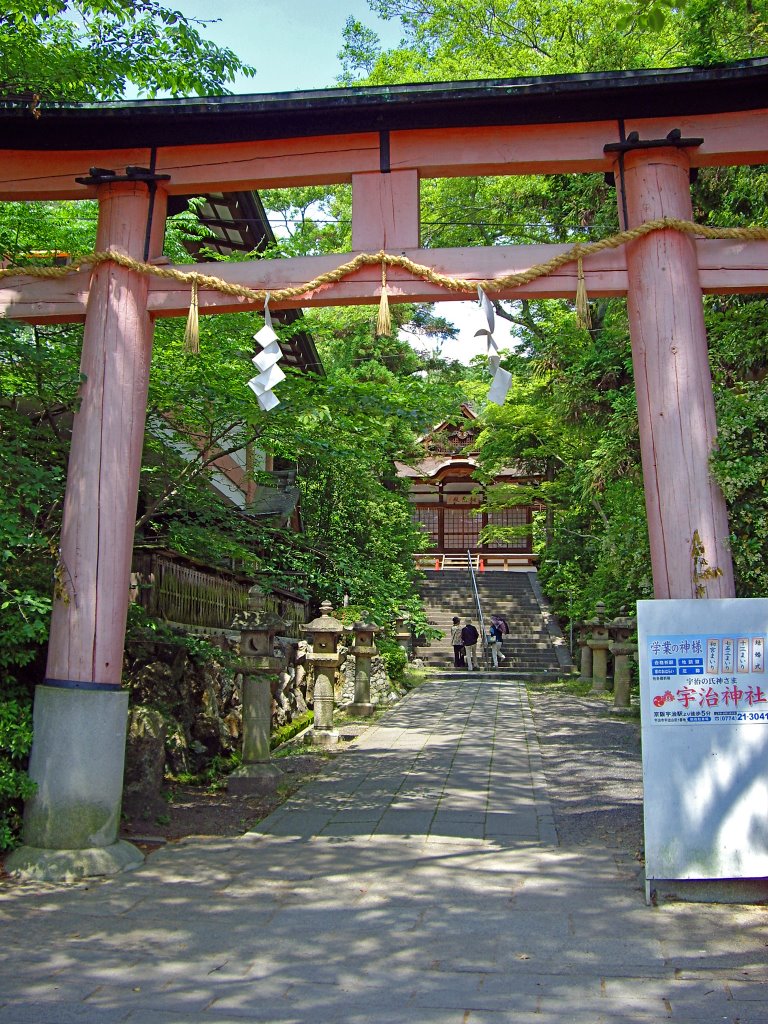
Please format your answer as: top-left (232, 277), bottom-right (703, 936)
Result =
top-left (7, 181), bottom-right (165, 881)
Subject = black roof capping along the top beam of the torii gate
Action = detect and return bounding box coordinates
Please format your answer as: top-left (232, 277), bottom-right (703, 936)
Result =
top-left (0, 57), bottom-right (768, 151)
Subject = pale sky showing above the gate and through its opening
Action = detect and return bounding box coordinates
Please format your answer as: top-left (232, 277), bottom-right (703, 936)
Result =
top-left (173, 0), bottom-right (513, 362)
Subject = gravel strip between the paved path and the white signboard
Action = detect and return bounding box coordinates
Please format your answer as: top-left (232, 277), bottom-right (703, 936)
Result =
top-left (528, 684), bottom-right (643, 858)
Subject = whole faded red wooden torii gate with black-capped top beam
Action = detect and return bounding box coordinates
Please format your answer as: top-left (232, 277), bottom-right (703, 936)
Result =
top-left (0, 59), bottom-right (768, 877)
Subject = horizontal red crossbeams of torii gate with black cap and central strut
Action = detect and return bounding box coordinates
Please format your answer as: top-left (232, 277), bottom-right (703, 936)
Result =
top-left (0, 58), bottom-right (768, 322)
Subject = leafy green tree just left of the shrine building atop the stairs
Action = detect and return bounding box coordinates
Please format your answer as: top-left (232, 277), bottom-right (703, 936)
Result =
top-left (274, 308), bottom-right (461, 625)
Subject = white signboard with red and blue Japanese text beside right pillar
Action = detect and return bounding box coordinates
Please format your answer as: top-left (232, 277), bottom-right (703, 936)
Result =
top-left (638, 598), bottom-right (768, 880)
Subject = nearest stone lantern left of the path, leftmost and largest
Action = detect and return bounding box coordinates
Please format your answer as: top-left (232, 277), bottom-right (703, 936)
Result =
top-left (227, 587), bottom-right (286, 793)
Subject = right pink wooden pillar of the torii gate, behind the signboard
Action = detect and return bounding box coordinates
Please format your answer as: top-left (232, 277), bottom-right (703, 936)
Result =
top-left (615, 144), bottom-right (735, 599)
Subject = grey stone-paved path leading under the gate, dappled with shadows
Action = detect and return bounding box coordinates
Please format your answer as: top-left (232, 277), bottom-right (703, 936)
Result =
top-left (0, 676), bottom-right (768, 1024)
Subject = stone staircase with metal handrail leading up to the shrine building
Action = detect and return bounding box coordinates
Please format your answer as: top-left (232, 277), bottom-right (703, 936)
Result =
top-left (418, 568), bottom-right (570, 675)
